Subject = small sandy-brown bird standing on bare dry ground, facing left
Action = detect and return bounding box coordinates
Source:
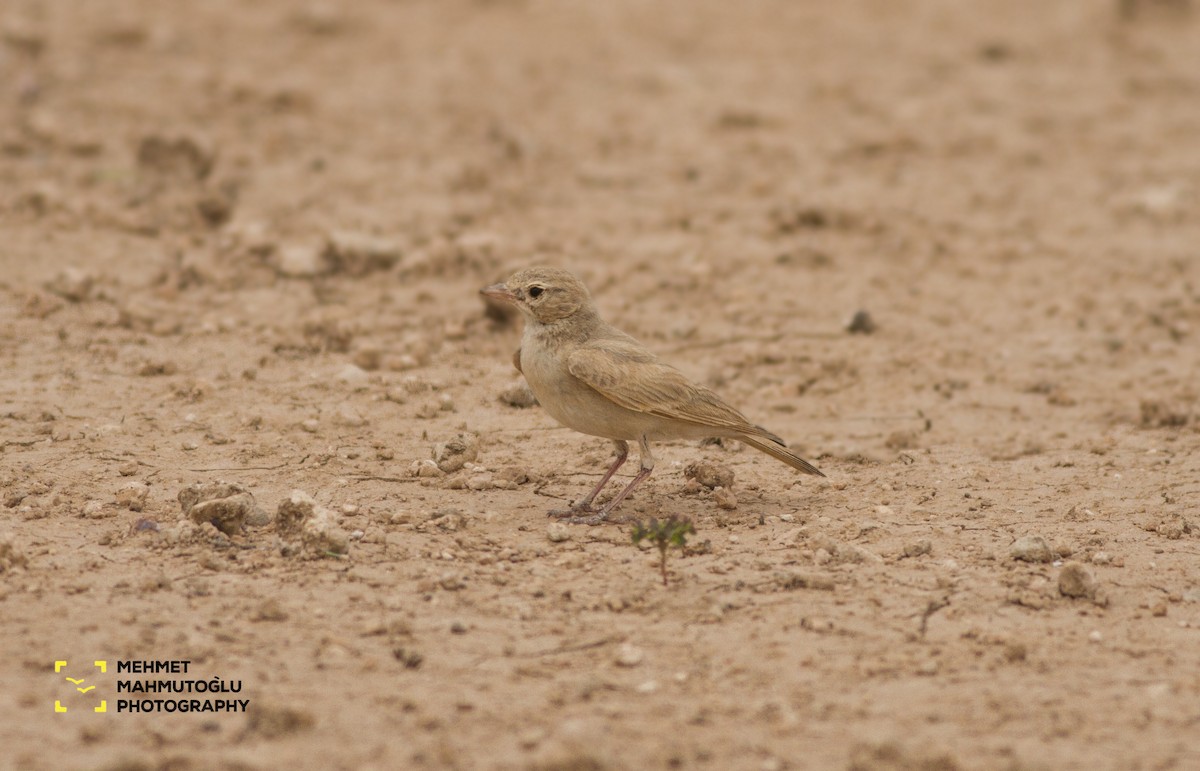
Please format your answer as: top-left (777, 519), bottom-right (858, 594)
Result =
top-left (480, 267), bottom-right (824, 525)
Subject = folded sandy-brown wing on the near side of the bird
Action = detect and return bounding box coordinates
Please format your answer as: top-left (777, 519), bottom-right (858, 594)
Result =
top-left (566, 339), bottom-right (753, 436)
